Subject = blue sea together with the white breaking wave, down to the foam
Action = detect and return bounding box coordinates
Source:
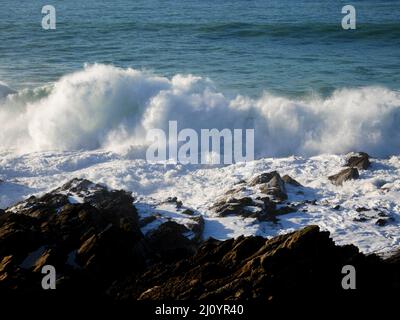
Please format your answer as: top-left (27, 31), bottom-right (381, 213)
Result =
top-left (0, 0), bottom-right (400, 157)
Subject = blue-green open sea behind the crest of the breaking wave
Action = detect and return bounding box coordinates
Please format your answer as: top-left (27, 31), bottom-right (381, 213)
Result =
top-left (0, 0), bottom-right (400, 96)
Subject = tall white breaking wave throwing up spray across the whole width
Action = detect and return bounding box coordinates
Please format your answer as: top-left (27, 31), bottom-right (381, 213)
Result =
top-left (0, 65), bottom-right (400, 157)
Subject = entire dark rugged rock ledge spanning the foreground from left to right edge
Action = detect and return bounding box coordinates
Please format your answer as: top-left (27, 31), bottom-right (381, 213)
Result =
top-left (0, 179), bottom-right (400, 304)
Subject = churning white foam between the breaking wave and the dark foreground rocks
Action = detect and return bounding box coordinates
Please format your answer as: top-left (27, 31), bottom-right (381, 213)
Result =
top-left (0, 150), bottom-right (400, 252)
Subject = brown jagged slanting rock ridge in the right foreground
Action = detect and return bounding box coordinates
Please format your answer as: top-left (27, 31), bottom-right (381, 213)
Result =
top-left (113, 226), bottom-right (400, 303)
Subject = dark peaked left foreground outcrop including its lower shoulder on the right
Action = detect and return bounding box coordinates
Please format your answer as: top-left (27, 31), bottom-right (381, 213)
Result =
top-left (0, 179), bottom-right (204, 295)
